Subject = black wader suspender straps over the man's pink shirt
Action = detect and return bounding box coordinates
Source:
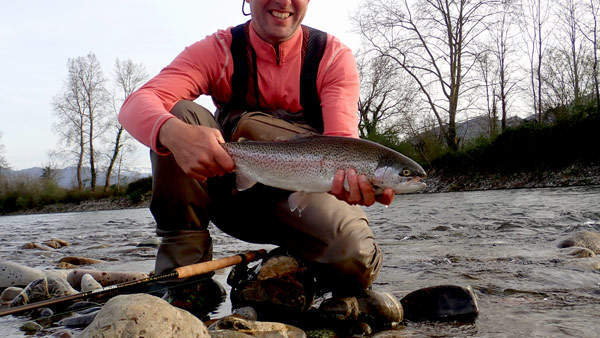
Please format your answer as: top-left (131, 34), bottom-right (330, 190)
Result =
top-left (216, 21), bottom-right (327, 140)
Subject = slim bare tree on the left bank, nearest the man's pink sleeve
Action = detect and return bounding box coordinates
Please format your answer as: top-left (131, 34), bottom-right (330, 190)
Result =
top-left (104, 59), bottom-right (148, 191)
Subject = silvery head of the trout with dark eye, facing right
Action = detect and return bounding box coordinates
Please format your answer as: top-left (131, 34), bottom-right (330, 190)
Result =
top-left (371, 153), bottom-right (427, 194)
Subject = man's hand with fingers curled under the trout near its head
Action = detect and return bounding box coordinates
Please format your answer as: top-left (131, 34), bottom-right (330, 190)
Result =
top-left (329, 169), bottom-right (394, 206)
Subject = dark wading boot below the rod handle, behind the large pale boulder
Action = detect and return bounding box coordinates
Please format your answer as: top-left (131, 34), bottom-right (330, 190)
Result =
top-left (163, 278), bottom-right (227, 320)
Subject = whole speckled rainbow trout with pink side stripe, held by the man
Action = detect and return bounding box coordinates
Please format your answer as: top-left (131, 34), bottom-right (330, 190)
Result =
top-left (223, 136), bottom-right (426, 211)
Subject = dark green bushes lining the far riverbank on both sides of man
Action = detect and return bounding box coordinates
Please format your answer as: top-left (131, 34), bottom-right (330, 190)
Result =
top-left (0, 103), bottom-right (600, 214)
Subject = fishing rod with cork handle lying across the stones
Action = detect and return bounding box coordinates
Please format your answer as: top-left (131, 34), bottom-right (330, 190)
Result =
top-left (0, 249), bottom-right (267, 317)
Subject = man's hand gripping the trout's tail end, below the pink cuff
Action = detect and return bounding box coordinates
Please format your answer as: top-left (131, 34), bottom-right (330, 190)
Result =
top-left (158, 118), bottom-right (235, 181)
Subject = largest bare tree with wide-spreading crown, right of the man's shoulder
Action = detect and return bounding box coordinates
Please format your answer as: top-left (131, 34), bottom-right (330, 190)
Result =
top-left (355, 0), bottom-right (493, 150)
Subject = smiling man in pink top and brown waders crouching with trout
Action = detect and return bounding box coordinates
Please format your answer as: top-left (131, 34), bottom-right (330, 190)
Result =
top-left (119, 0), bottom-right (393, 316)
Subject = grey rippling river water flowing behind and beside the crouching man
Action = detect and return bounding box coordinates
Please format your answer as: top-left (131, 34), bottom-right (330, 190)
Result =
top-left (0, 186), bottom-right (600, 337)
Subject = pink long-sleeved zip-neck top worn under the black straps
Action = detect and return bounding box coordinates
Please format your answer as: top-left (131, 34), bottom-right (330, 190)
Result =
top-left (119, 23), bottom-right (359, 154)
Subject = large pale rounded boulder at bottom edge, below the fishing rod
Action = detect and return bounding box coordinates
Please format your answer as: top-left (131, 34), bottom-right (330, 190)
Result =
top-left (79, 294), bottom-right (210, 338)
